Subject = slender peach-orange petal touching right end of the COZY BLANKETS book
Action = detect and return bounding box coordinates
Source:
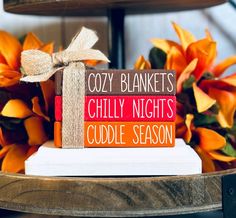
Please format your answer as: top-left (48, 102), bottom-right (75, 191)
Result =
top-left (176, 58), bottom-right (198, 93)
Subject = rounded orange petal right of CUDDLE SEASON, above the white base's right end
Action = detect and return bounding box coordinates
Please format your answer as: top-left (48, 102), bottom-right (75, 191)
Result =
top-left (196, 127), bottom-right (226, 151)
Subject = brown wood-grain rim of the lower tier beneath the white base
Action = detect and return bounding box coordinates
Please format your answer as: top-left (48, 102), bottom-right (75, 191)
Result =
top-left (0, 170), bottom-right (236, 217)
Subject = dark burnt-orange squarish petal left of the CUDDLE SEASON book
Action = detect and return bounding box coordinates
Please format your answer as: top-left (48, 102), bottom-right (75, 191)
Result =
top-left (24, 116), bottom-right (48, 145)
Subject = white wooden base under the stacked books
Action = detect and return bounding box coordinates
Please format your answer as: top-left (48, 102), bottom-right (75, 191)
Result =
top-left (25, 139), bottom-right (202, 176)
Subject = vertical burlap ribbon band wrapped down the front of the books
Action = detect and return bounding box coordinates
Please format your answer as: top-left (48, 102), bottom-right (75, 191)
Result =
top-left (62, 63), bottom-right (85, 148)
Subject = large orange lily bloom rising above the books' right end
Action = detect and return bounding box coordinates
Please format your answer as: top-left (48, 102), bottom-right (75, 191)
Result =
top-left (151, 23), bottom-right (216, 81)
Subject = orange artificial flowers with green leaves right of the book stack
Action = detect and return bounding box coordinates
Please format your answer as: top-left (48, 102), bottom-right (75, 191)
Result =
top-left (134, 23), bottom-right (236, 172)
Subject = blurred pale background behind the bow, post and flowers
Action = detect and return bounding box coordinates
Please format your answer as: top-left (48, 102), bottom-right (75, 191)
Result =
top-left (0, 0), bottom-right (236, 73)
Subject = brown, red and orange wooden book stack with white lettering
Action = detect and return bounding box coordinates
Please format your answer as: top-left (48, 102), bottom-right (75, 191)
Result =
top-left (54, 70), bottom-right (176, 147)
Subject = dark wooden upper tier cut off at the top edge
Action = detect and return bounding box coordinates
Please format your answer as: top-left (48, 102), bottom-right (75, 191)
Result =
top-left (4, 0), bottom-right (226, 16)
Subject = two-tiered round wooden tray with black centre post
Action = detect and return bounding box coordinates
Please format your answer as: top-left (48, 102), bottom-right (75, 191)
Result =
top-left (0, 0), bottom-right (236, 217)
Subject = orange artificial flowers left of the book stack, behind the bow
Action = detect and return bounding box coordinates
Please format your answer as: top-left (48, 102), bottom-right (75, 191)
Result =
top-left (0, 31), bottom-right (54, 173)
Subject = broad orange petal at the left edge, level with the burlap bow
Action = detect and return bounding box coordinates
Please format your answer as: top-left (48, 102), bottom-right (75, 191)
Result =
top-left (0, 31), bottom-right (22, 70)
